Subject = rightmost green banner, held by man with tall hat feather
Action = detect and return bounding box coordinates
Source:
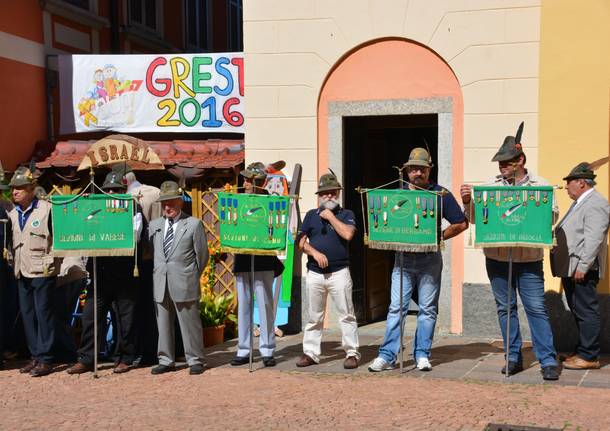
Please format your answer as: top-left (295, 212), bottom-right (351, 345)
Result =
top-left (473, 186), bottom-right (553, 248)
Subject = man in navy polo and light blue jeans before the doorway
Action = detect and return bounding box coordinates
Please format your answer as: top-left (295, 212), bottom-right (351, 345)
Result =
top-left (369, 148), bottom-right (468, 372)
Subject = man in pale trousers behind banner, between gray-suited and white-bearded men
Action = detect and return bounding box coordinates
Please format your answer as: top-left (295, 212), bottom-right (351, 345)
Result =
top-left (231, 162), bottom-right (284, 367)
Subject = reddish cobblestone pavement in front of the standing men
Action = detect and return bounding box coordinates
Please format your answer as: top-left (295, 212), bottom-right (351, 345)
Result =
top-left (0, 327), bottom-right (610, 430)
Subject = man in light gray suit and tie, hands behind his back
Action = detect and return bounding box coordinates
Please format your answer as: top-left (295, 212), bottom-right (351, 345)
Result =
top-left (149, 181), bottom-right (208, 374)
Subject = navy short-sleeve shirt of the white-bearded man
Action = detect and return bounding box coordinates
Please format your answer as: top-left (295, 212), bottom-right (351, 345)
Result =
top-left (301, 208), bottom-right (356, 274)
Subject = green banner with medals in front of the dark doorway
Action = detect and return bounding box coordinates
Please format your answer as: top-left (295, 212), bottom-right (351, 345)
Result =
top-left (365, 189), bottom-right (440, 252)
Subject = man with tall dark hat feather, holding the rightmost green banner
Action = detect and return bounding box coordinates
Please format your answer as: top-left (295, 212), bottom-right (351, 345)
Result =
top-left (460, 123), bottom-right (559, 380)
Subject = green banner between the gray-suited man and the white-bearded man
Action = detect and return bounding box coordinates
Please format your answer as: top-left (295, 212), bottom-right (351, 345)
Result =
top-left (218, 192), bottom-right (290, 255)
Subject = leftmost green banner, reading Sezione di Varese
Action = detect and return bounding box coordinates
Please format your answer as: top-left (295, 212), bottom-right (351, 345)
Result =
top-left (51, 194), bottom-right (135, 256)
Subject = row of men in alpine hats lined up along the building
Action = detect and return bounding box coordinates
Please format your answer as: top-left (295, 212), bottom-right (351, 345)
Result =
top-left (0, 121), bottom-right (610, 380)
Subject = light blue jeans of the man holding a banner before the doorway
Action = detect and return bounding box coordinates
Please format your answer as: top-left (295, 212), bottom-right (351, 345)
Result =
top-left (379, 252), bottom-right (443, 364)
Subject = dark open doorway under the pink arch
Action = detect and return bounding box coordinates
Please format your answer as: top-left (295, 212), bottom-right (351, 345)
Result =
top-left (343, 114), bottom-right (438, 323)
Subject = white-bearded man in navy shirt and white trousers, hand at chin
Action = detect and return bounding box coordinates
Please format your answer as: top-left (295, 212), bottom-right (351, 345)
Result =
top-left (297, 173), bottom-right (360, 369)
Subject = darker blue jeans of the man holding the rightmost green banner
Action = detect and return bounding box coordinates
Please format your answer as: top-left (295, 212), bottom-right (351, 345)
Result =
top-left (485, 259), bottom-right (557, 367)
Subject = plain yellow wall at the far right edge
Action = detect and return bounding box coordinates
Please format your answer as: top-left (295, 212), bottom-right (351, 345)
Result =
top-left (540, 0), bottom-right (610, 293)
